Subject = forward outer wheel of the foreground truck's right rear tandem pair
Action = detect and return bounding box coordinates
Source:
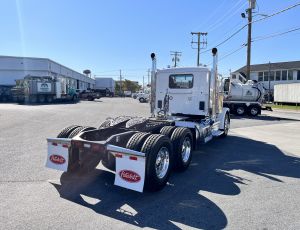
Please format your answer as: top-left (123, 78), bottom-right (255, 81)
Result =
top-left (171, 127), bottom-right (193, 171)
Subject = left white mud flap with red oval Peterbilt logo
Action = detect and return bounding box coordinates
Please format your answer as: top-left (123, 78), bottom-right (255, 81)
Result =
top-left (46, 138), bottom-right (71, 172)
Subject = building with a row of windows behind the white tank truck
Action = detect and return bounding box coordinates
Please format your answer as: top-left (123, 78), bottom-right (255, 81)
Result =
top-left (232, 61), bottom-right (300, 91)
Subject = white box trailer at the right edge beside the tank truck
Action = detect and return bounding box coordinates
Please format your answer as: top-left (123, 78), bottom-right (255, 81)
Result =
top-left (274, 83), bottom-right (300, 104)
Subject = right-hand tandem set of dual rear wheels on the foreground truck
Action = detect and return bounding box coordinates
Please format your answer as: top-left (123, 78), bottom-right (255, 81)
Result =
top-left (121, 126), bottom-right (193, 191)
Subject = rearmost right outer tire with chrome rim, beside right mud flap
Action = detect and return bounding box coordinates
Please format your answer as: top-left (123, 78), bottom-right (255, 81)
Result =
top-left (141, 134), bottom-right (173, 191)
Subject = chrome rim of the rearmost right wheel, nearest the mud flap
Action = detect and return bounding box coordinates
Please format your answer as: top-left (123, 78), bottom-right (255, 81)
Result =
top-left (155, 147), bottom-right (170, 179)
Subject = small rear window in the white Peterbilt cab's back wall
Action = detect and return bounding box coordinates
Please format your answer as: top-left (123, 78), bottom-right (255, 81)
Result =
top-left (169, 74), bottom-right (194, 89)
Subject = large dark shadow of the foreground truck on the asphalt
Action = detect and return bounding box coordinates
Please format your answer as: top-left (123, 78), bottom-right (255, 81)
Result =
top-left (53, 136), bottom-right (300, 229)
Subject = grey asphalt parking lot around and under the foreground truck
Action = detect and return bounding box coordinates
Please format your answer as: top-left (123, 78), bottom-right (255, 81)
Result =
top-left (0, 98), bottom-right (300, 229)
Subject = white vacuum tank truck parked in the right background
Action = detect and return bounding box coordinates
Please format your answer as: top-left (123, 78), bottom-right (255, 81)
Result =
top-left (223, 75), bottom-right (265, 116)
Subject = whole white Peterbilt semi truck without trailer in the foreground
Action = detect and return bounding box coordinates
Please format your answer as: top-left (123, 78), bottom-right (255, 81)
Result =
top-left (46, 48), bottom-right (230, 192)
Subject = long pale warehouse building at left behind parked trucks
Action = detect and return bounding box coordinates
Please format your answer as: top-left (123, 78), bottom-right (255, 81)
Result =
top-left (0, 56), bottom-right (95, 90)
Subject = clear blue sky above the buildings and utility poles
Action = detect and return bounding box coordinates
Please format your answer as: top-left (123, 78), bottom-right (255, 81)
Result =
top-left (0, 0), bottom-right (300, 82)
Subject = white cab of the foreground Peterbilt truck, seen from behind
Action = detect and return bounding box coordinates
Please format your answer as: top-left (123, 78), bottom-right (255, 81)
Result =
top-left (155, 67), bottom-right (222, 117)
